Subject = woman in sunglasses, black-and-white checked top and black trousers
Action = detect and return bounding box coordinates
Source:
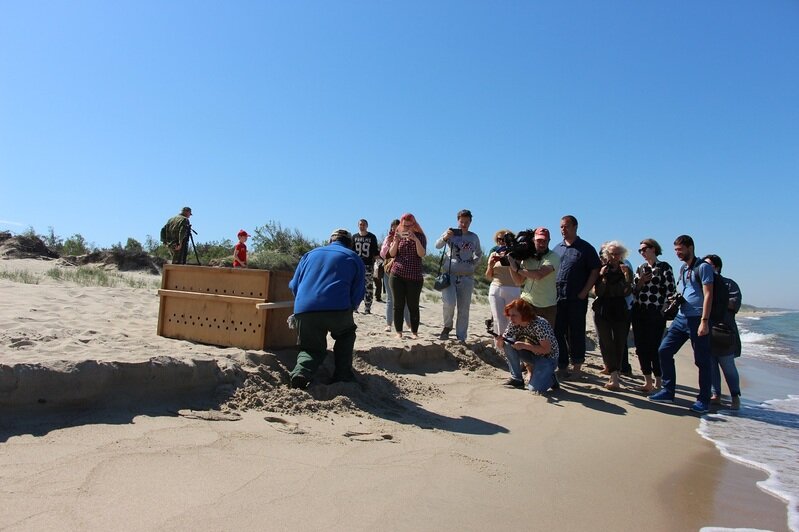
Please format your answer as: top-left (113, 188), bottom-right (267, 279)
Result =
top-left (632, 238), bottom-right (677, 393)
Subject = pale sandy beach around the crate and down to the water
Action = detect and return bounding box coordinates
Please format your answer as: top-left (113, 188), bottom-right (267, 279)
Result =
top-left (0, 259), bottom-right (786, 530)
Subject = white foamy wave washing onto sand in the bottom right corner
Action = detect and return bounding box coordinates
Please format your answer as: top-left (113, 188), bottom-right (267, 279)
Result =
top-left (697, 395), bottom-right (799, 531)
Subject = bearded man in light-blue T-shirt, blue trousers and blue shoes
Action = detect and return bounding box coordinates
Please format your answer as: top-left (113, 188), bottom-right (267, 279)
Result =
top-left (649, 235), bottom-right (714, 414)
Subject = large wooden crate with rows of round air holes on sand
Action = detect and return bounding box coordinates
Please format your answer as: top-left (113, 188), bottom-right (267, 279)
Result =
top-left (158, 264), bottom-right (297, 349)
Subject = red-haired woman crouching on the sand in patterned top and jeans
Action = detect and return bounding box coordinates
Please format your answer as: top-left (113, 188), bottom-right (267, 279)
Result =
top-left (497, 298), bottom-right (560, 395)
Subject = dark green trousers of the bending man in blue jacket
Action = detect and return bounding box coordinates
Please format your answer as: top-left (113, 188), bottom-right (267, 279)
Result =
top-left (291, 310), bottom-right (356, 380)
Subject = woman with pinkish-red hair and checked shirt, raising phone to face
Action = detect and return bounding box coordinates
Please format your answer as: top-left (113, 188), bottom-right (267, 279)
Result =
top-left (388, 213), bottom-right (427, 338)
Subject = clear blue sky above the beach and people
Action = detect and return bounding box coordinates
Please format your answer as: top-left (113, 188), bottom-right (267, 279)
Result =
top-left (0, 0), bottom-right (799, 308)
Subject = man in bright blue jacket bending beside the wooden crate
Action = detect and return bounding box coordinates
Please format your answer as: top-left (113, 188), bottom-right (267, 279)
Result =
top-left (289, 229), bottom-right (365, 390)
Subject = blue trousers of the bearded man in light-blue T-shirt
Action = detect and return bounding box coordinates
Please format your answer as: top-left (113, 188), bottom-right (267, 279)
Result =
top-left (658, 314), bottom-right (711, 404)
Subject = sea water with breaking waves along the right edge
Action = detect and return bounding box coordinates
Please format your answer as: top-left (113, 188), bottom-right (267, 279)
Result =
top-left (698, 311), bottom-right (799, 531)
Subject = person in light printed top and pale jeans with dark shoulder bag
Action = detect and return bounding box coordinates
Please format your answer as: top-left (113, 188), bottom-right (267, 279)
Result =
top-left (436, 209), bottom-right (483, 342)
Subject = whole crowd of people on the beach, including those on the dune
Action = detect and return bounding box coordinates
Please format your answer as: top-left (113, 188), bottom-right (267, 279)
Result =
top-left (162, 208), bottom-right (741, 413)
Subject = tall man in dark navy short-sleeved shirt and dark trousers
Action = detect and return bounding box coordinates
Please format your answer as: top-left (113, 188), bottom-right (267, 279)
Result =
top-left (552, 215), bottom-right (602, 379)
